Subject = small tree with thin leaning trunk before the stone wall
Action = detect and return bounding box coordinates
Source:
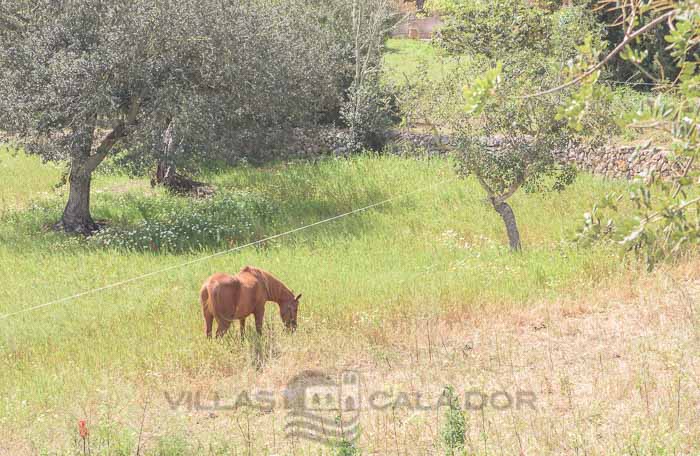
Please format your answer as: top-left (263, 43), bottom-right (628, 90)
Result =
top-left (456, 65), bottom-right (576, 251)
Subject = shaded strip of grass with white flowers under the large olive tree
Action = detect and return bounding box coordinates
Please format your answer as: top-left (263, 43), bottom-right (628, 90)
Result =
top-left (0, 172), bottom-right (404, 254)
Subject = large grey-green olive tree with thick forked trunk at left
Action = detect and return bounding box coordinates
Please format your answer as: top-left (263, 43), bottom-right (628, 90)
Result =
top-left (0, 0), bottom-right (392, 233)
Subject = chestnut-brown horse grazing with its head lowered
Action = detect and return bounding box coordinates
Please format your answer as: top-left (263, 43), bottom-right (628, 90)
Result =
top-left (199, 266), bottom-right (301, 338)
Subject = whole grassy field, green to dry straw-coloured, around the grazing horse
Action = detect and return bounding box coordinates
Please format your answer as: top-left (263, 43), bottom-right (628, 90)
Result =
top-left (0, 145), bottom-right (700, 455)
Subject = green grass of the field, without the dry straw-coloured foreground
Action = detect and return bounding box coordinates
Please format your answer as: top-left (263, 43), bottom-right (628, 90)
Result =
top-left (0, 148), bottom-right (680, 454)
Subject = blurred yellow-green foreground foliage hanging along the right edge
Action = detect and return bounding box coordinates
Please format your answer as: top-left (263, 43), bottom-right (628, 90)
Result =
top-left (579, 1), bottom-right (700, 269)
